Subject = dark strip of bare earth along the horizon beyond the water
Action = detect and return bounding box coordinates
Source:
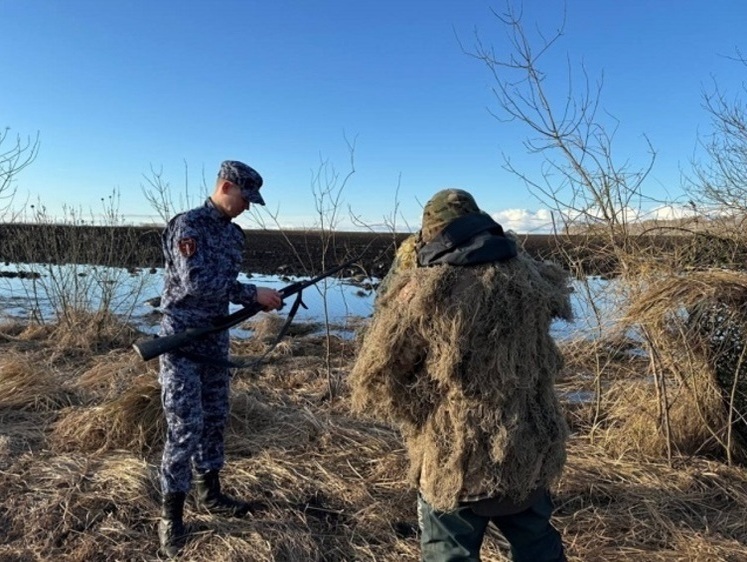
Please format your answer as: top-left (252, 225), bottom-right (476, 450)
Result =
top-left (5, 224), bottom-right (747, 277)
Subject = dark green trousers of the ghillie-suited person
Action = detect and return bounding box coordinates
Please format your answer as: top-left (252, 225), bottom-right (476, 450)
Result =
top-left (418, 493), bottom-right (566, 562)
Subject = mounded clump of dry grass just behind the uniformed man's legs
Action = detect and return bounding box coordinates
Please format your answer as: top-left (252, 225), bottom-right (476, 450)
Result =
top-left (51, 375), bottom-right (165, 454)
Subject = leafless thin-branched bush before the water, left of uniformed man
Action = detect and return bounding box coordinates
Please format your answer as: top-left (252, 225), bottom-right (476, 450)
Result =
top-left (14, 189), bottom-right (153, 341)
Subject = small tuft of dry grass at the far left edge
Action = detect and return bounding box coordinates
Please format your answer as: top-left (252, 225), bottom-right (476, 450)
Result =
top-left (0, 352), bottom-right (76, 411)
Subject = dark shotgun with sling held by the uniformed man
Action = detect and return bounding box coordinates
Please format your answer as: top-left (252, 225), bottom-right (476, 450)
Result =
top-left (132, 256), bottom-right (360, 361)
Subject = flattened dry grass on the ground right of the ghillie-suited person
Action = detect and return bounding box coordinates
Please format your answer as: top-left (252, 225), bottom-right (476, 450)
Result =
top-left (556, 439), bottom-right (747, 562)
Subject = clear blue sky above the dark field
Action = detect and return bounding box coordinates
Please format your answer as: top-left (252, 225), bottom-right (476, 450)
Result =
top-left (0, 0), bottom-right (747, 232)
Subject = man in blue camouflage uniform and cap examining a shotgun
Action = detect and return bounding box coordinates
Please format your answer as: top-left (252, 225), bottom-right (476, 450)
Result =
top-left (158, 160), bottom-right (282, 557)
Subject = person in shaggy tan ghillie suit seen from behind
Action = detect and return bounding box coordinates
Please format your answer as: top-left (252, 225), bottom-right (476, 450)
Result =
top-left (349, 189), bottom-right (571, 562)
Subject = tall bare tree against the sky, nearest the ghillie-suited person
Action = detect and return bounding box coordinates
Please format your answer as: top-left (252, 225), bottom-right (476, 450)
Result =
top-left (462, 3), bottom-right (655, 276)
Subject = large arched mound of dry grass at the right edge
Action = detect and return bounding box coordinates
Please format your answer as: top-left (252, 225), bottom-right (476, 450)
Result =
top-left (620, 270), bottom-right (747, 461)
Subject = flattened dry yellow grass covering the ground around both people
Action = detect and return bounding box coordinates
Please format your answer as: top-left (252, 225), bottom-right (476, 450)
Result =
top-left (0, 316), bottom-right (747, 562)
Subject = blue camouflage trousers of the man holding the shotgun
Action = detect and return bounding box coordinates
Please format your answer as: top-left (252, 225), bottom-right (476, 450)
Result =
top-left (158, 332), bottom-right (230, 494)
